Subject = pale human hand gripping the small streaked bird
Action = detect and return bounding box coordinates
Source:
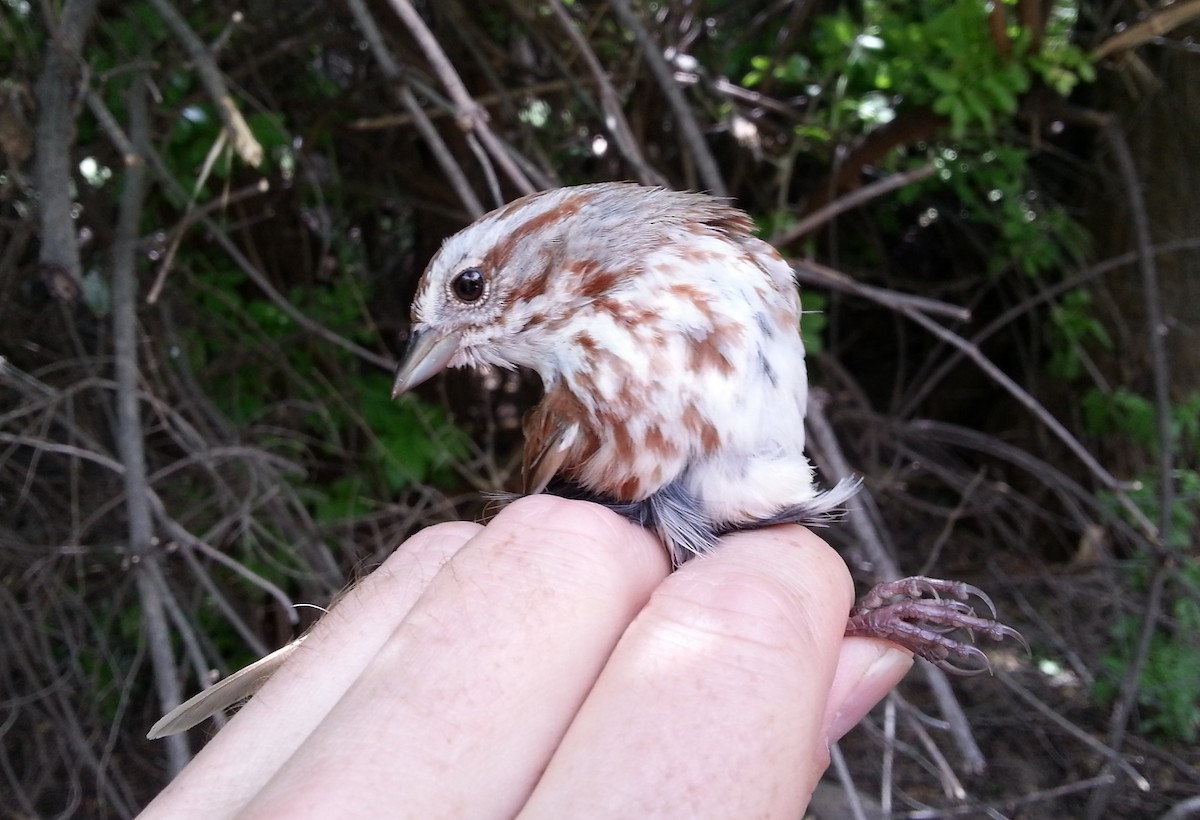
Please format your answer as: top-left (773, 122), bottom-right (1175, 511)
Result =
top-left (143, 496), bottom-right (912, 820)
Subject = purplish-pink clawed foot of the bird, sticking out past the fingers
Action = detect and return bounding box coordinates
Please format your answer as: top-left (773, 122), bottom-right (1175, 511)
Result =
top-left (846, 576), bottom-right (1030, 675)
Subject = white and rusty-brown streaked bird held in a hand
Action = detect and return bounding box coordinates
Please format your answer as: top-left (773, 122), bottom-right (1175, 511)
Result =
top-left (149, 182), bottom-right (1024, 737)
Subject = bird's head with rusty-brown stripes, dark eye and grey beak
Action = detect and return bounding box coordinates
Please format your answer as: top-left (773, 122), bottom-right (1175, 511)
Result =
top-left (392, 182), bottom-right (750, 395)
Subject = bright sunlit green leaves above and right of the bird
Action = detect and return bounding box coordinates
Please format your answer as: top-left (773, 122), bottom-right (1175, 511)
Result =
top-left (733, 0), bottom-right (1094, 282)
